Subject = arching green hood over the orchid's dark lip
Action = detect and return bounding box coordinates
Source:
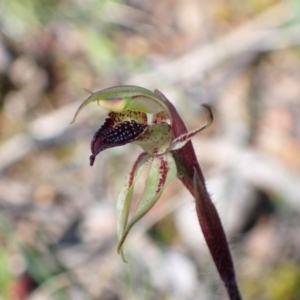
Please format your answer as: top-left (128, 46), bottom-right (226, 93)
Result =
top-left (71, 85), bottom-right (170, 124)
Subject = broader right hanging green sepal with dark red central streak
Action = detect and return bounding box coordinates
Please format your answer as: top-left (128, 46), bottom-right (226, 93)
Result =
top-left (118, 153), bottom-right (177, 254)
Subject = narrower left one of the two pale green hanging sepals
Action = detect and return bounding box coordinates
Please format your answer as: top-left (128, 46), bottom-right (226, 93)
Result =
top-left (117, 152), bottom-right (150, 261)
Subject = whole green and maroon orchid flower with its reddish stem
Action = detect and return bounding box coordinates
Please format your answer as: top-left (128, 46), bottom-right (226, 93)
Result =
top-left (72, 86), bottom-right (241, 300)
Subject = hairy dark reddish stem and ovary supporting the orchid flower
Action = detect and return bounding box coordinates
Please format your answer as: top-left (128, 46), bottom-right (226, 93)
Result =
top-left (155, 90), bottom-right (242, 300)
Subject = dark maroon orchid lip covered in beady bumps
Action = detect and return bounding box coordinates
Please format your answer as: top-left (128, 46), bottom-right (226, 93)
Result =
top-left (90, 118), bottom-right (148, 166)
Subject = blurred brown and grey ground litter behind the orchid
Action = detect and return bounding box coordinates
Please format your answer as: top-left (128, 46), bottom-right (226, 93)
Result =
top-left (0, 0), bottom-right (300, 300)
